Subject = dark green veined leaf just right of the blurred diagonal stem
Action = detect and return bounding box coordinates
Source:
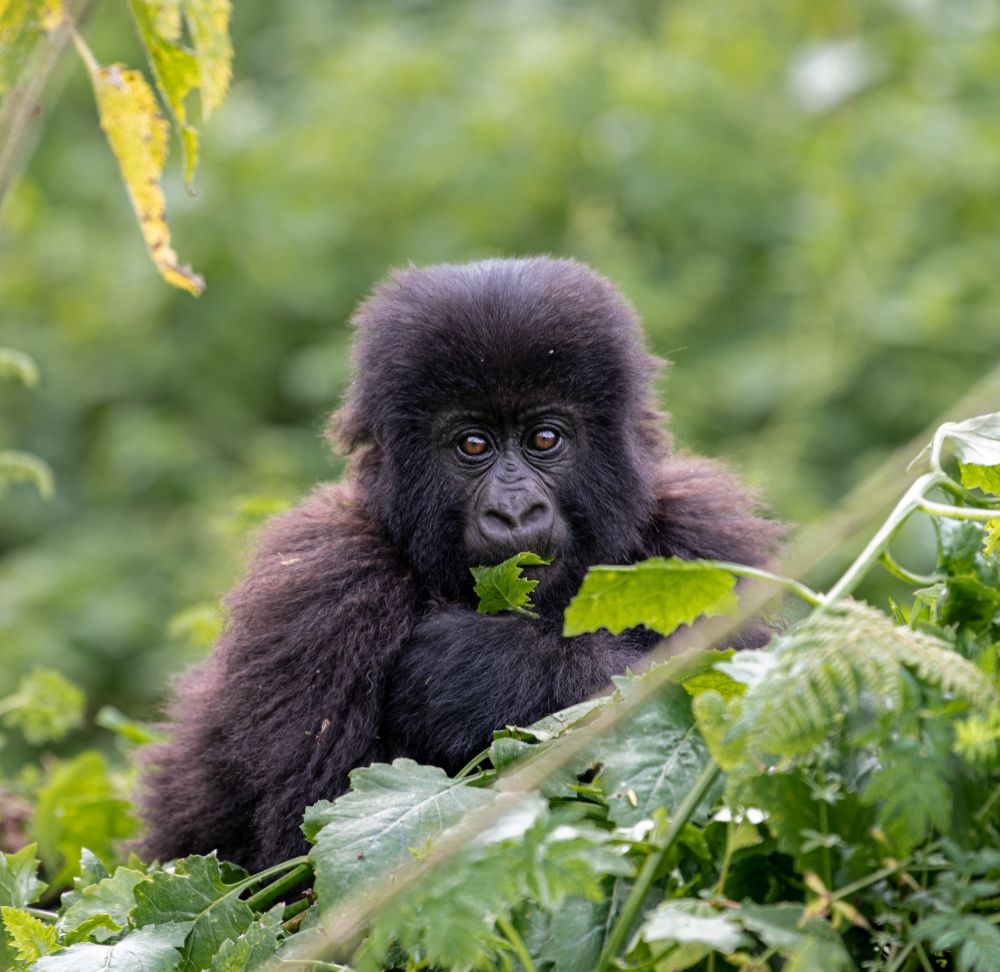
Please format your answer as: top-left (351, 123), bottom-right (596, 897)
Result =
top-left (595, 678), bottom-right (722, 827)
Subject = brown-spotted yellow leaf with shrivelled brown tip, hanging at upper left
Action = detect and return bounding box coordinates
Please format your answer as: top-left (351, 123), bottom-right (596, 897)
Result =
top-left (74, 35), bottom-right (205, 296)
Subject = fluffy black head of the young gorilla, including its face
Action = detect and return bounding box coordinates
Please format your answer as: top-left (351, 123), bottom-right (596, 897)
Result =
top-left (333, 258), bottom-right (664, 610)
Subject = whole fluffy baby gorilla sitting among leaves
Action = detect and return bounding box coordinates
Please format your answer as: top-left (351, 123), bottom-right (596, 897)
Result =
top-left (144, 257), bottom-right (780, 870)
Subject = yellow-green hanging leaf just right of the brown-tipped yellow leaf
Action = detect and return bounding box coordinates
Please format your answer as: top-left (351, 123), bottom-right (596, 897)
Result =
top-left (129, 0), bottom-right (201, 185)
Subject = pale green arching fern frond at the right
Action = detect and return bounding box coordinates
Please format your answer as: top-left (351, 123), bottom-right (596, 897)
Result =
top-left (727, 601), bottom-right (1000, 755)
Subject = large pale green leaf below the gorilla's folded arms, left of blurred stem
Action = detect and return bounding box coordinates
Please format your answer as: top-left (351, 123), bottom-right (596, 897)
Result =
top-left (303, 759), bottom-right (495, 910)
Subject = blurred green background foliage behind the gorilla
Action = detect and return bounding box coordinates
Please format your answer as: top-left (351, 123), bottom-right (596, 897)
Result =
top-left (0, 0), bottom-right (1000, 761)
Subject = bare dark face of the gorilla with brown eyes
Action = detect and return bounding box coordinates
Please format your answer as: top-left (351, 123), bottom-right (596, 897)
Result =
top-left (436, 406), bottom-right (582, 572)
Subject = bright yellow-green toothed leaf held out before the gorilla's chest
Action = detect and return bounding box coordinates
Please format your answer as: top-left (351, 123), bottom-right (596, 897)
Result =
top-left (563, 557), bottom-right (738, 638)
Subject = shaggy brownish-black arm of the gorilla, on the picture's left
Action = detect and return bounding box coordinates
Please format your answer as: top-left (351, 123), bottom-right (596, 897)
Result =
top-left (142, 486), bottom-right (421, 869)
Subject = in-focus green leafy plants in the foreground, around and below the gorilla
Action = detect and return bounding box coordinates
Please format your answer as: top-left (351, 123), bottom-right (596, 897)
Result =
top-left (0, 413), bottom-right (1000, 972)
